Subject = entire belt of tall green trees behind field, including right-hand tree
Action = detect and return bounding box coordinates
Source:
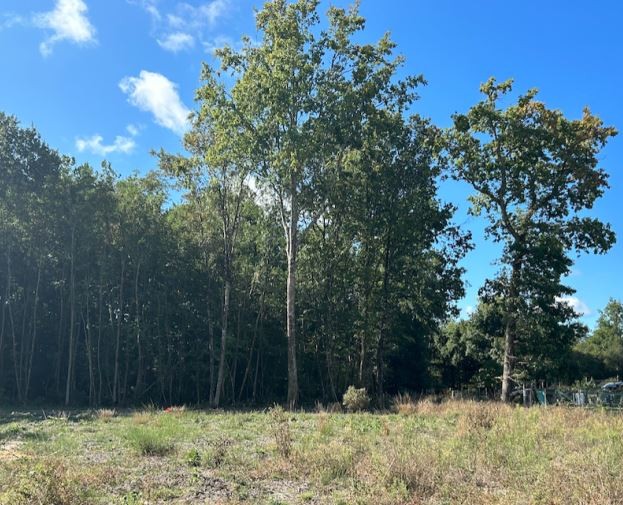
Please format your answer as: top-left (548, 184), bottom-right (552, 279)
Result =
top-left (0, 0), bottom-right (623, 407)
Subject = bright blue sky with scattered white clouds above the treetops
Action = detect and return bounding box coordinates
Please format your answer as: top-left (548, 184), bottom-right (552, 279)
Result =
top-left (0, 0), bottom-right (623, 325)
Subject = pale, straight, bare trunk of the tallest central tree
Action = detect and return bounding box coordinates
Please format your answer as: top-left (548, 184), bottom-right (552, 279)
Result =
top-left (286, 179), bottom-right (299, 409)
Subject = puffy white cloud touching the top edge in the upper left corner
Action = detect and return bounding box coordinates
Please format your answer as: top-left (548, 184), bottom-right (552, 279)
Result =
top-left (33, 0), bottom-right (96, 56)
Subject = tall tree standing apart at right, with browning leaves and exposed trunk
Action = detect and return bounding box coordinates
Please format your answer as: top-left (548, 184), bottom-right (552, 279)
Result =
top-left (448, 78), bottom-right (616, 401)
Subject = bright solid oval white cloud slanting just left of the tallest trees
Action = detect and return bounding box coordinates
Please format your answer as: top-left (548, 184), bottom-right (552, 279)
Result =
top-left (119, 70), bottom-right (190, 135)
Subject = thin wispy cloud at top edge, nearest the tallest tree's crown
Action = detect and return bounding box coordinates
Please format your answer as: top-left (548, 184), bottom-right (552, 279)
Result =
top-left (128, 0), bottom-right (233, 53)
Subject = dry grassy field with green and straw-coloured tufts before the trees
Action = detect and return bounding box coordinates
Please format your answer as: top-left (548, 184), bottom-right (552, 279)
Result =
top-left (0, 401), bottom-right (623, 505)
